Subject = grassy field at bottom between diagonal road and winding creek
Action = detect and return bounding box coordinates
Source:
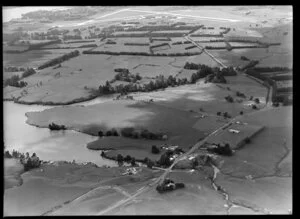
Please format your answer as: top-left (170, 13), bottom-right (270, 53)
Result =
top-left (109, 172), bottom-right (226, 215)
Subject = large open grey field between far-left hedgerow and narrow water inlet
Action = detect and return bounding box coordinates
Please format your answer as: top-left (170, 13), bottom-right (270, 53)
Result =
top-left (4, 54), bottom-right (190, 104)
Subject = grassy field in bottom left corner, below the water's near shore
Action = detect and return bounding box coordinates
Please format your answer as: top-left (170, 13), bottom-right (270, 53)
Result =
top-left (4, 163), bottom-right (131, 216)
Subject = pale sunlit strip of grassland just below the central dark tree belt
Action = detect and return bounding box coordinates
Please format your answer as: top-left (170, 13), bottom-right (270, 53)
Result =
top-left (133, 76), bottom-right (267, 116)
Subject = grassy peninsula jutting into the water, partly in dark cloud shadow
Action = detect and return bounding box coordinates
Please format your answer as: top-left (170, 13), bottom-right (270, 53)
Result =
top-left (27, 100), bottom-right (207, 155)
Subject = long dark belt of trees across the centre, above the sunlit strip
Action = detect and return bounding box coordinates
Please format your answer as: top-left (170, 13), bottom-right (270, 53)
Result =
top-left (99, 62), bottom-right (237, 95)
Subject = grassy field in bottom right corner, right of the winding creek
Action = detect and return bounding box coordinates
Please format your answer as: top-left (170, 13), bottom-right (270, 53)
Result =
top-left (217, 174), bottom-right (293, 214)
